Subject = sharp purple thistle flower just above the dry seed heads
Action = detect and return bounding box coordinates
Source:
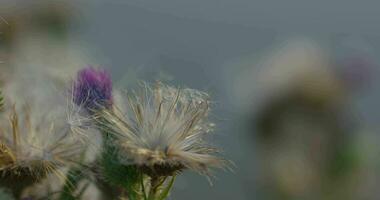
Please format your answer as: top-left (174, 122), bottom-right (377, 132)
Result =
top-left (72, 66), bottom-right (112, 111)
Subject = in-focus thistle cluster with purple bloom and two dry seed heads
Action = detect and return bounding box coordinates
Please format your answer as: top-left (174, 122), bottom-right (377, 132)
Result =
top-left (0, 67), bottom-right (228, 200)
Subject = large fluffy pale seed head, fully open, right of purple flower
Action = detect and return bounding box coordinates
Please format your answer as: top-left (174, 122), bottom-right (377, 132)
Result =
top-left (99, 83), bottom-right (225, 176)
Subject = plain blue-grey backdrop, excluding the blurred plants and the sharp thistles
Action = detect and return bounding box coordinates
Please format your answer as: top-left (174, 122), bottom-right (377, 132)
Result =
top-left (67, 0), bottom-right (380, 200)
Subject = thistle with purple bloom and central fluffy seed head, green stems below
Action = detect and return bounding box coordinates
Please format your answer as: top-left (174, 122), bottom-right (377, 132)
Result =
top-left (71, 67), bottom-right (226, 200)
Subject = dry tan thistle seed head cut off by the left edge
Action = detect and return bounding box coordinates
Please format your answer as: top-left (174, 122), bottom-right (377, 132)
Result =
top-left (0, 106), bottom-right (83, 190)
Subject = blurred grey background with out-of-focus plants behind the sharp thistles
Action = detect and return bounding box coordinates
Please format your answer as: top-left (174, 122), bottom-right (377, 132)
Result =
top-left (0, 0), bottom-right (380, 200)
